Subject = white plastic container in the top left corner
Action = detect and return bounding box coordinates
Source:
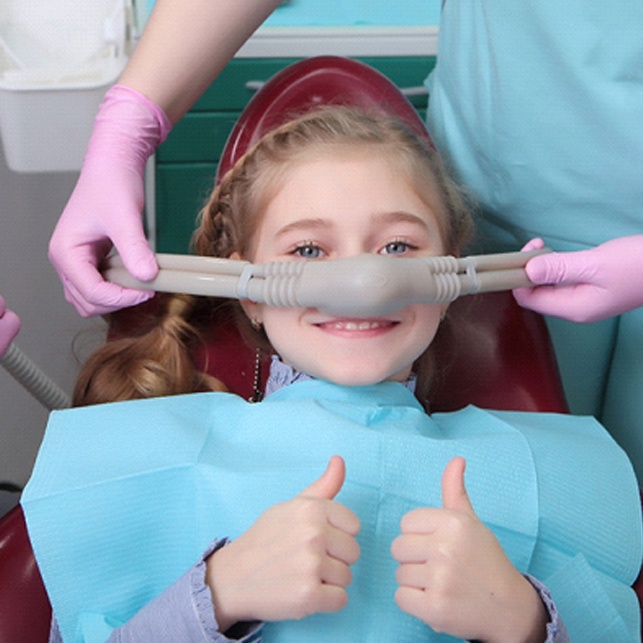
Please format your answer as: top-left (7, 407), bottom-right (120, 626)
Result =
top-left (0, 0), bottom-right (132, 172)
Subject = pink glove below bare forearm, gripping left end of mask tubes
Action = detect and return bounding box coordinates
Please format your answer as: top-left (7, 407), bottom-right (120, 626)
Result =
top-left (49, 85), bottom-right (172, 317)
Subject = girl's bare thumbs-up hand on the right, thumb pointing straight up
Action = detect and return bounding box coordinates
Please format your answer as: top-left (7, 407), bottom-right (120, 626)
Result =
top-left (391, 458), bottom-right (547, 642)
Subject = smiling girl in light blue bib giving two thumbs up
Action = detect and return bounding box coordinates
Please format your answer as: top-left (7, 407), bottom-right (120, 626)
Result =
top-left (23, 107), bottom-right (641, 642)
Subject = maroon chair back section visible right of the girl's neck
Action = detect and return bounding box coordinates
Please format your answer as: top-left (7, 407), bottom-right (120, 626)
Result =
top-left (429, 292), bottom-right (568, 413)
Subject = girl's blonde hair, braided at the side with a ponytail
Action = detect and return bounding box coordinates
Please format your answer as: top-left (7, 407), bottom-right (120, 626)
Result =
top-left (74, 106), bottom-right (472, 405)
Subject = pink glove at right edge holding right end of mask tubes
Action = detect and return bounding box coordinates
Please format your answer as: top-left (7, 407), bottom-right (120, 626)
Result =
top-left (514, 235), bottom-right (643, 322)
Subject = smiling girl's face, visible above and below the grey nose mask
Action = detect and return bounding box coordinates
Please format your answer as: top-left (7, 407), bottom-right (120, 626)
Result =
top-left (244, 150), bottom-right (446, 386)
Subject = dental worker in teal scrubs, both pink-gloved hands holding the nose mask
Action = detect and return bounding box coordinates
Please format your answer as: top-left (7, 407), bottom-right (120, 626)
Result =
top-left (49, 0), bottom-right (643, 478)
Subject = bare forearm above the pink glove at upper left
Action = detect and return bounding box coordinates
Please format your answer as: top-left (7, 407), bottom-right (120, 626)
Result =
top-left (119, 0), bottom-right (280, 123)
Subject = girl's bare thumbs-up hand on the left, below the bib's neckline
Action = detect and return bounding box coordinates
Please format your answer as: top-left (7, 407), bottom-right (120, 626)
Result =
top-left (206, 456), bottom-right (360, 632)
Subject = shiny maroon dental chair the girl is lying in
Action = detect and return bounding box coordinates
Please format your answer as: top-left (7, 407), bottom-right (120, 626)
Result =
top-left (0, 57), bottom-right (643, 643)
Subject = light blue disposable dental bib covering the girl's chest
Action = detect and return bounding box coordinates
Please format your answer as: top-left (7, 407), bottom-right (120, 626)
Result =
top-left (22, 380), bottom-right (642, 643)
